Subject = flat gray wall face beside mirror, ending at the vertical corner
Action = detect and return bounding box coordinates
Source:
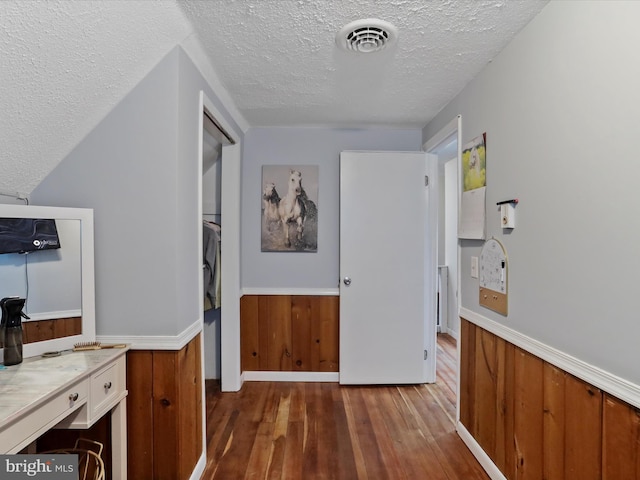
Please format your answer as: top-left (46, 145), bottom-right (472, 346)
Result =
top-left (31, 50), bottom-right (178, 335)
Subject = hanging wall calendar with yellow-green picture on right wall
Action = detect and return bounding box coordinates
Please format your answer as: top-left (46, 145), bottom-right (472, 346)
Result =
top-left (458, 133), bottom-right (487, 240)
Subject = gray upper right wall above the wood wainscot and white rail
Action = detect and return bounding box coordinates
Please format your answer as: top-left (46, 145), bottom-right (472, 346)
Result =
top-left (423, 1), bottom-right (640, 384)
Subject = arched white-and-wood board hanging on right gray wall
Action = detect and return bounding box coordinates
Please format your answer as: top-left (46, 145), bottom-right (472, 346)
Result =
top-left (479, 238), bottom-right (509, 315)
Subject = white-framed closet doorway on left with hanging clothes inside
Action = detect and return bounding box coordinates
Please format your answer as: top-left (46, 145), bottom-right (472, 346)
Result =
top-left (194, 91), bottom-right (241, 464)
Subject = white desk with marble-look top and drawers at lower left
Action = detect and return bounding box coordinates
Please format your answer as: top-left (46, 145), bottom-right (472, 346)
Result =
top-left (0, 348), bottom-right (127, 480)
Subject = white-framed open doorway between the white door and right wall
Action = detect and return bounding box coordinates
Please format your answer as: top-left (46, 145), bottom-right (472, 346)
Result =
top-left (424, 115), bottom-right (461, 421)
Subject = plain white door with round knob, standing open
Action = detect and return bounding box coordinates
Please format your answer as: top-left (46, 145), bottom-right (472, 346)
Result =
top-left (340, 152), bottom-right (437, 384)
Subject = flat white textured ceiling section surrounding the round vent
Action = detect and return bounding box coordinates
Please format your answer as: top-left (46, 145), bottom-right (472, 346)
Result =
top-left (181, 0), bottom-right (546, 127)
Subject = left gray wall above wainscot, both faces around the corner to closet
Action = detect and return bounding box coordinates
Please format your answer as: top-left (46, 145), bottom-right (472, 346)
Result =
top-left (31, 47), bottom-right (244, 336)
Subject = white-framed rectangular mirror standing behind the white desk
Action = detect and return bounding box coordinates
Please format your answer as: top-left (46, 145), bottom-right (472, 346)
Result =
top-left (0, 205), bottom-right (95, 358)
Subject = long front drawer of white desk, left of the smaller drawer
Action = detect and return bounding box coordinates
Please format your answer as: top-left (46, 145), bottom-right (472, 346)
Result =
top-left (0, 380), bottom-right (89, 453)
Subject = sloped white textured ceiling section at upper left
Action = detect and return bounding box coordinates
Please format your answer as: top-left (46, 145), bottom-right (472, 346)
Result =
top-left (0, 0), bottom-right (192, 195)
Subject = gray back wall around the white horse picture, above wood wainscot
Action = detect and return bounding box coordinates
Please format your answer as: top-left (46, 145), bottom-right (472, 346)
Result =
top-left (242, 127), bottom-right (422, 289)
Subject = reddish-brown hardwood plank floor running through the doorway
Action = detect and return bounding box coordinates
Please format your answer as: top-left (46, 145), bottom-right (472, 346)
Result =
top-left (202, 335), bottom-right (488, 480)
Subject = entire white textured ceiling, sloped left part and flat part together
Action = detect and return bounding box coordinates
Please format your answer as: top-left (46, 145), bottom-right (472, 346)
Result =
top-left (0, 0), bottom-right (546, 194)
